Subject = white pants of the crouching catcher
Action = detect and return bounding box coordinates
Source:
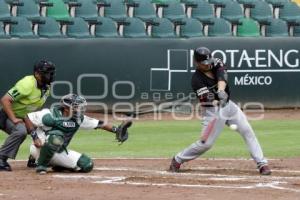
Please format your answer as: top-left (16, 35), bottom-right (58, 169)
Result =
top-left (30, 129), bottom-right (82, 170)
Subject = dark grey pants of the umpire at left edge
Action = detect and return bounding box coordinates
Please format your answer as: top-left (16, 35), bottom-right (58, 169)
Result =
top-left (0, 109), bottom-right (27, 159)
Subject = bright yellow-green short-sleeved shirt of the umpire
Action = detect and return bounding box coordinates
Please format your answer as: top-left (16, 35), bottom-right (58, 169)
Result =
top-left (7, 75), bottom-right (50, 118)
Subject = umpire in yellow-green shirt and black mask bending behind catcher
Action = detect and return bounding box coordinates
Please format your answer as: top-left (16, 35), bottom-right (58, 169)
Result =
top-left (0, 60), bottom-right (55, 171)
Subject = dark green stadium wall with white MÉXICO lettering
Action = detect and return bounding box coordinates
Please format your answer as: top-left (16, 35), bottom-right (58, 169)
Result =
top-left (0, 38), bottom-right (300, 107)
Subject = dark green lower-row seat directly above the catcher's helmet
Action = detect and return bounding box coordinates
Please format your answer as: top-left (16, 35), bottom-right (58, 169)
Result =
top-left (66, 17), bottom-right (93, 38)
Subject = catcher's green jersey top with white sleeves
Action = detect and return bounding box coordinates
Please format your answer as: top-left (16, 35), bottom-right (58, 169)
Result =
top-left (28, 106), bottom-right (99, 147)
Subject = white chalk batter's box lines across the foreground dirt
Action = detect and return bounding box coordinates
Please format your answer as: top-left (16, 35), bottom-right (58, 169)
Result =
top-left (53, 167), bottom-right (300, 193)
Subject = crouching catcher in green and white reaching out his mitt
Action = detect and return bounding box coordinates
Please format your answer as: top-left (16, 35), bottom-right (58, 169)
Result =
top-left (25, 94), bottom-right (132, 174)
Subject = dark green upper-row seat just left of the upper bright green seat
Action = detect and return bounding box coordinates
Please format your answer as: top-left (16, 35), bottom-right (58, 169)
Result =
top-left (17, 0), bottom-right (40, 19)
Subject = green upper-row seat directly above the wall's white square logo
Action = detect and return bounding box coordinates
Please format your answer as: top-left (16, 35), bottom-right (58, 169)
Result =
top-left (162, 1), bottom-right (186, 22)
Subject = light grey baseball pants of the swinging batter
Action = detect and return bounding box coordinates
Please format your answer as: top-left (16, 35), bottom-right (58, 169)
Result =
top-left (175, 101), bottom-right (267, 165)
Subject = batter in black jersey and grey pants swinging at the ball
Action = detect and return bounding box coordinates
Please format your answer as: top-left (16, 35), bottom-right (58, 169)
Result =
top-left (170, 47), bottom-right (271, 175)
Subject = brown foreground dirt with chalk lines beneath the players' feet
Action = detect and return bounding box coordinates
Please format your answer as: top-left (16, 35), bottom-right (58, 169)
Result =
top-left (0, 159), bottom-right (300, 200)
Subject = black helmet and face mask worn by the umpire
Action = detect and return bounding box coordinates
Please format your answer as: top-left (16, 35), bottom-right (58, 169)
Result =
top-left (33, 60), bottom-right (55, 85)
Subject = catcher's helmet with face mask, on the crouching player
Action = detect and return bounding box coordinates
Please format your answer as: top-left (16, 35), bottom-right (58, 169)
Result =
top-left (60, 94), bottom-right (87, 118)
